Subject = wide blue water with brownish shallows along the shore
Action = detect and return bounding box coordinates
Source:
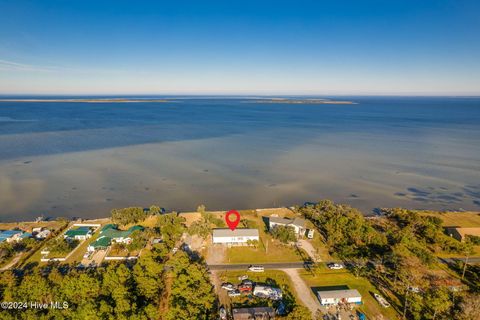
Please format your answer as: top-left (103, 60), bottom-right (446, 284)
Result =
top-left (0, 97), bottom-right (480, 220)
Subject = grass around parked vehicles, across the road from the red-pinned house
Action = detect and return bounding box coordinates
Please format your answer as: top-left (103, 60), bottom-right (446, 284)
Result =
top-left (218, 270), bottom-right (302, 307)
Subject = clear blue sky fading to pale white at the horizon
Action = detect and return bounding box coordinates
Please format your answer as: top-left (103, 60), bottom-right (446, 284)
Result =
top-left (0, 0), bottom-right (480, 95)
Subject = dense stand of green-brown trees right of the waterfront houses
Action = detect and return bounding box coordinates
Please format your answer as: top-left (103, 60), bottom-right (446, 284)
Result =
top-left (296, 200), bottom-right (480, 320)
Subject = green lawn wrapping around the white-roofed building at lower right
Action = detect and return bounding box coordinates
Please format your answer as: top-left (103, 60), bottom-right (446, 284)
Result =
top-left (299, 268), bottom-right (399, 319)
